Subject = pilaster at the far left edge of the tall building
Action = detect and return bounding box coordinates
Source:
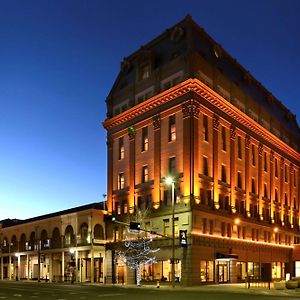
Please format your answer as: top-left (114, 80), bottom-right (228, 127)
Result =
top-left (106, 135), bottom-right (113, 214)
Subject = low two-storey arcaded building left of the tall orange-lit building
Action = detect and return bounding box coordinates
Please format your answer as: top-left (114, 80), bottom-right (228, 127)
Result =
top-left (0, 203), bottom-right (111, 283)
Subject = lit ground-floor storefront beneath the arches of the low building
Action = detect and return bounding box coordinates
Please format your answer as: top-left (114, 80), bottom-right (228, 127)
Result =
top-left (0, 246), bottom-right (107, 283)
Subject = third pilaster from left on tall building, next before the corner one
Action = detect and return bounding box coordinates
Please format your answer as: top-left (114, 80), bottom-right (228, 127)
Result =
top-left (152, 114), bottom-right (161, 208)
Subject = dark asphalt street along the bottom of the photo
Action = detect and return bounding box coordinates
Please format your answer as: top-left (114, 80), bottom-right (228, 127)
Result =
top-left (0, 282), bottom-right (299, 300)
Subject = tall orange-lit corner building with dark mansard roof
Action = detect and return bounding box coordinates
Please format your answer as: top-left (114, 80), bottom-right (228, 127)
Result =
top-left (104, 16), bottom-right (300, 286)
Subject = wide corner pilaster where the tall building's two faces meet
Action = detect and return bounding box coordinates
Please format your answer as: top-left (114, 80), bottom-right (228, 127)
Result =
top-left (182, 100), bottom-right (200, 201)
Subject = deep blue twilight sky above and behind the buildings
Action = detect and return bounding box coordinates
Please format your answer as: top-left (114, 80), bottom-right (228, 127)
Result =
top-left (0, 0), bottom-right (300, 220)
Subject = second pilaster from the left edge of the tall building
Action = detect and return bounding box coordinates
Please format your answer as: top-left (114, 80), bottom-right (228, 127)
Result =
top-left (128, 126), bottom-right (136, 214)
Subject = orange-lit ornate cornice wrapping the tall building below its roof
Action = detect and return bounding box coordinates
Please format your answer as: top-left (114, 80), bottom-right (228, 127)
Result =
top-left (103, 79), bottom-right (300, 161)
